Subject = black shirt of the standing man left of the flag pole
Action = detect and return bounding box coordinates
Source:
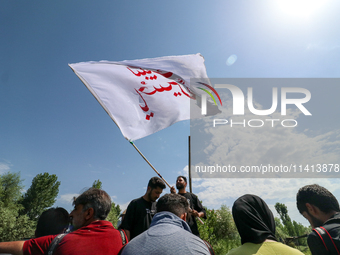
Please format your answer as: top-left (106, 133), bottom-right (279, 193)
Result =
top-left (121, 197), bottom-right (156, 240)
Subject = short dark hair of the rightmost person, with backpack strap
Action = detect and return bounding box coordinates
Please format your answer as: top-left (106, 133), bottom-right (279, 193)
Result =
top-left (296, 184), bottom-right (340, 214)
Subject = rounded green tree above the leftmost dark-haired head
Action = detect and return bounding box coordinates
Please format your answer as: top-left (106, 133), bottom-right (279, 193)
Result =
top-left (20, 173), bottom-right (60, 221)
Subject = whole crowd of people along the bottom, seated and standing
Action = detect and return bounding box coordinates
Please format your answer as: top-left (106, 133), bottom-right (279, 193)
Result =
top-left (0, 176), bottom-right (340, 255)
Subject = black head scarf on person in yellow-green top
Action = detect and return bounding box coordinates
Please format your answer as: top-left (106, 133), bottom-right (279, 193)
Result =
top-left (232, 195), bottom-right (277, 244)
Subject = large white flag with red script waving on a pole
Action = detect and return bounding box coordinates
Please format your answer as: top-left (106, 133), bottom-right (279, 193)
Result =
top-left (69, 54), bottom-right (218, 140)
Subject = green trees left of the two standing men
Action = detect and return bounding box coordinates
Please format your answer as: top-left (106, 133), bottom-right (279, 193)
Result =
top-left (0, 172), bottom-right (120, 242)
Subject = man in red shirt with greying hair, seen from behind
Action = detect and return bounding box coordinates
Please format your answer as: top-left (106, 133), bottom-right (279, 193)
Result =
top-left (0, 188), bottom-right (123, 255)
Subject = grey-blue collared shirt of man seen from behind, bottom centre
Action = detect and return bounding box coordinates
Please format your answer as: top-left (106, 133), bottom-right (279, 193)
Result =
top-left (122, 212), bottom-right (210, 255)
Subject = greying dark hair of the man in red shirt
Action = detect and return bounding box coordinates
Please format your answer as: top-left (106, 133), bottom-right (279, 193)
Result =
top-left (73, 188), bottom-right (111, 220)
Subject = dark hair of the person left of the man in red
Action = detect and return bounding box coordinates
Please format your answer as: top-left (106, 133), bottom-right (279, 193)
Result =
top-left (35, 207), bottom-right (70, 237)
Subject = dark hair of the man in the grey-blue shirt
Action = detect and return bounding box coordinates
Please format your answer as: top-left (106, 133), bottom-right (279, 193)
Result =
top-left (156, 193), bottom-right (189, 217)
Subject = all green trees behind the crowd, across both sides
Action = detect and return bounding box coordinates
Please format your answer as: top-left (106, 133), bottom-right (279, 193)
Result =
top-left (0, 172), bottom-right (311, 255)
